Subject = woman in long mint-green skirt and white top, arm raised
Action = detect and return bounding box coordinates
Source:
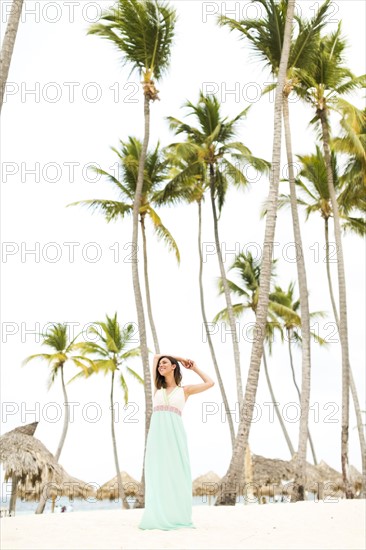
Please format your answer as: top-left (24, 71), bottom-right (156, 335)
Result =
top-left (139, 355), bottom-right (214, 531)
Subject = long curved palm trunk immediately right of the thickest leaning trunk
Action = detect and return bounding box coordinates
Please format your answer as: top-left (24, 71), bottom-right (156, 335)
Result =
top-left (283, 96), bottom-right (311, 502)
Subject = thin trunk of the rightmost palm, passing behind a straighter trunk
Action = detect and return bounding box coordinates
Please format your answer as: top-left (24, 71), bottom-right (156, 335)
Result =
top-left (325, 218), bottom-right (366, 498)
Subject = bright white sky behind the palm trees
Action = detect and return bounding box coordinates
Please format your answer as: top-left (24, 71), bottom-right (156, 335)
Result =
top-left (1, 0), bottom-right (365, 492)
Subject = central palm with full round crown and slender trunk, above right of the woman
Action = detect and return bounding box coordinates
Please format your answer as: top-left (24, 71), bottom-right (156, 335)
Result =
top-left (168, 92), bottom-right (268, 404)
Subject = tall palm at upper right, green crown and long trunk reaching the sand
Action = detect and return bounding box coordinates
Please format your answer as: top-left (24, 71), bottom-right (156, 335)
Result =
top-left (297, 22), bottom-right (365, 498)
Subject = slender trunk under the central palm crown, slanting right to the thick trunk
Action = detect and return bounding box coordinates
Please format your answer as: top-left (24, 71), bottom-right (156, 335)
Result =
top-left (210, 164), bottom-right (243, 407)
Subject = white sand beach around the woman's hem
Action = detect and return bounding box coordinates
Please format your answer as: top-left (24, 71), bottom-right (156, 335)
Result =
top-left (1, 500), bottom-right (366, 550)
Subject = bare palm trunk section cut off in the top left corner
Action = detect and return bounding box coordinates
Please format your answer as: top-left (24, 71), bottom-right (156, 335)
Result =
top-left (0, 0), bottom-right (24, 112)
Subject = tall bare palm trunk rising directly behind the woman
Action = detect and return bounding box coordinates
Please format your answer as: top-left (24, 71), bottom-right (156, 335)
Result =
top-left (132, 93), bottom-right (152, 508)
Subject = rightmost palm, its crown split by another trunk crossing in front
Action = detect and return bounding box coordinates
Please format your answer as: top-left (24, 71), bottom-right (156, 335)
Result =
top-left (279, 146), bottom-right (366, 500)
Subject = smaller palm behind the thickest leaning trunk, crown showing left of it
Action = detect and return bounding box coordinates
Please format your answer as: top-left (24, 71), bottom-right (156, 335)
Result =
top-left (213, 252), bottom-right (295, 458)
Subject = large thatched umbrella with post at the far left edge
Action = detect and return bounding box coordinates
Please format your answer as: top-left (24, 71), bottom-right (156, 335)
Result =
top-left (0, 422), bottom-right (62, 515)
